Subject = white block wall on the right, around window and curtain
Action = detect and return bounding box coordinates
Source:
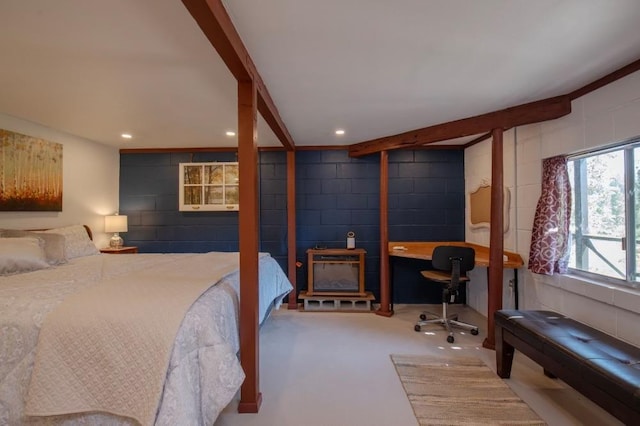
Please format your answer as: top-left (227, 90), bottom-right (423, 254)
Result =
top-left (465, 72), bottom-right (640, 346)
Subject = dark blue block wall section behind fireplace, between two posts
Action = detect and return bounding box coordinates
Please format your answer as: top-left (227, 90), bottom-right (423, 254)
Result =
top-left (296, 150), bottom-right (380, 295)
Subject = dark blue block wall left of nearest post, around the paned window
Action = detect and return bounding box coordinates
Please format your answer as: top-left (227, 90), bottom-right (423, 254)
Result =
top-left (120, 152), bottom-right (245, 253)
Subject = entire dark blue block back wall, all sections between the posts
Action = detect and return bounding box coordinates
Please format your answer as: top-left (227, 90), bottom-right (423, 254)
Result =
top-left (120, 149), bottom-right (465, 303)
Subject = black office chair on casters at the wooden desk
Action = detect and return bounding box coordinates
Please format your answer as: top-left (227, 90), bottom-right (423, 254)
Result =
top-left (414, 246), bottom-right (478, 343)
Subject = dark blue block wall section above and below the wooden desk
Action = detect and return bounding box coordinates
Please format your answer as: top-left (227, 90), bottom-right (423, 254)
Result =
top-left (389, 150), bottom-right (465, 303)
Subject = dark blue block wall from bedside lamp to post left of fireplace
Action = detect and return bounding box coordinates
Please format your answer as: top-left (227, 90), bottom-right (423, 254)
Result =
top-left (120, 151), bottom-right (287, 270)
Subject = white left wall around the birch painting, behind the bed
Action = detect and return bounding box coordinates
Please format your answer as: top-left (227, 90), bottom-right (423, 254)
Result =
top-left (0, 114), bottom-right (120, 247)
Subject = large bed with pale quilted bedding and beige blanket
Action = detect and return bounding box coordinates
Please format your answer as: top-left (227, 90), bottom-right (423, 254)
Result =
top-left (0, 225), bottom-right (292, 425)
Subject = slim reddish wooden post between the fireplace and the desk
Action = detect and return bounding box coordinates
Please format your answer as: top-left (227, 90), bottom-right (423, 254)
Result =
top-left (376, 151), bottom-right (393, 317)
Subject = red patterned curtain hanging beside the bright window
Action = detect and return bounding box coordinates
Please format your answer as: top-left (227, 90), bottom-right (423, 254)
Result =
top-left (529, 156), bottom-right (571, 275)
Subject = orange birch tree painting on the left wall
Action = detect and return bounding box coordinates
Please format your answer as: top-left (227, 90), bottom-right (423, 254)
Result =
top-left (0, 129), bottom-right (62, 211)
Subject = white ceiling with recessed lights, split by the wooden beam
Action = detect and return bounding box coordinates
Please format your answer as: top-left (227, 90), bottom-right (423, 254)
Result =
top-left (0, 0), bottom-right (640, 148)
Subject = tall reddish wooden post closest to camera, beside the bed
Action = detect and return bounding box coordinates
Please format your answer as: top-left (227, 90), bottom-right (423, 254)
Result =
top-left (238, 80), bottom-right (262, 413)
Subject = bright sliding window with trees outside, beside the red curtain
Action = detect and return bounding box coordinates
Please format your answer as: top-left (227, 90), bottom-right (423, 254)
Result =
top-left (568, 140), bottom-right (640, 287)
